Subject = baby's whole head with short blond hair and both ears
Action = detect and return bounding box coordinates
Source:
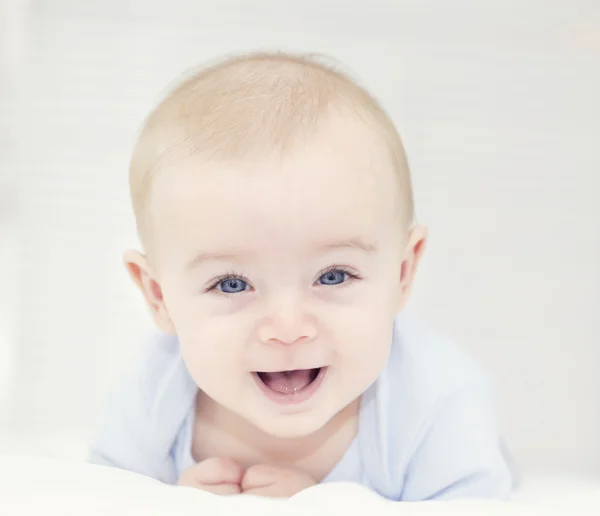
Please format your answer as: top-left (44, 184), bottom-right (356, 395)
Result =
top-left (126, 54), bottom-right (425, 437)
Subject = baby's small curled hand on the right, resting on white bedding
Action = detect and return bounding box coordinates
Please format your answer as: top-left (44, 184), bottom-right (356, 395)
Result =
top-left (241, 465), bottom-right (316, 498)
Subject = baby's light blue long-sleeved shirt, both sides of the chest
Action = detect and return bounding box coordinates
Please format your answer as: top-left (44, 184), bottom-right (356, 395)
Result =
top-left (90, 315), bottom-right (512, 501)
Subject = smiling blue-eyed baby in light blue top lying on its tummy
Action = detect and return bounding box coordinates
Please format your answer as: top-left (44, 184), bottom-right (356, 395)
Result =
top-left (90, 54), bottom-right (512, 501)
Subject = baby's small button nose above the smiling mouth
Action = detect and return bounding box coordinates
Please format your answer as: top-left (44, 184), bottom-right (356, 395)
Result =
top-left (258, 296), bottom-right (317, 345)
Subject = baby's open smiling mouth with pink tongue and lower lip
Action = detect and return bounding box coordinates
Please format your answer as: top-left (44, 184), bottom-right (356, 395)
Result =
top-left (252, 367), bottom-right (328, 403)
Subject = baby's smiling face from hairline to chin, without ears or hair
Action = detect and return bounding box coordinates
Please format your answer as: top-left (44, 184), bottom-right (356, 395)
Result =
top-left (152, 118), bottom-right (414, 437)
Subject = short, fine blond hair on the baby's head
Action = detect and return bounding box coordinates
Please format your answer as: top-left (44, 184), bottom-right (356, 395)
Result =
top-left (129, 53), bottom-right (414, 247)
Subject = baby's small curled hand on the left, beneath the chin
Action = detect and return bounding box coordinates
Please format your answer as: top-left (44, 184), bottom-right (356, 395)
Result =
top-left (177, 457), bottom-right (244, 495)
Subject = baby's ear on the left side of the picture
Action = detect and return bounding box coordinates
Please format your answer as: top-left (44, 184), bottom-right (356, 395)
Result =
top-left (123, 250), bottom-right (175, 335)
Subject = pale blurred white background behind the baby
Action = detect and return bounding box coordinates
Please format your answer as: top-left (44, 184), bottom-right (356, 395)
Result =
top-left (0, 0), bottom-right (600, 475)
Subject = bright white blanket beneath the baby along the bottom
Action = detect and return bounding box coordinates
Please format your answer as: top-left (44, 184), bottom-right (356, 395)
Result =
top-left (0, 456), bottom-right (600, 516)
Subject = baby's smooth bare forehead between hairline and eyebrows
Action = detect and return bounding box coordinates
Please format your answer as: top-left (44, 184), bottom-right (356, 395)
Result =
top-left (152, 114), bottom-right (400, 251)
